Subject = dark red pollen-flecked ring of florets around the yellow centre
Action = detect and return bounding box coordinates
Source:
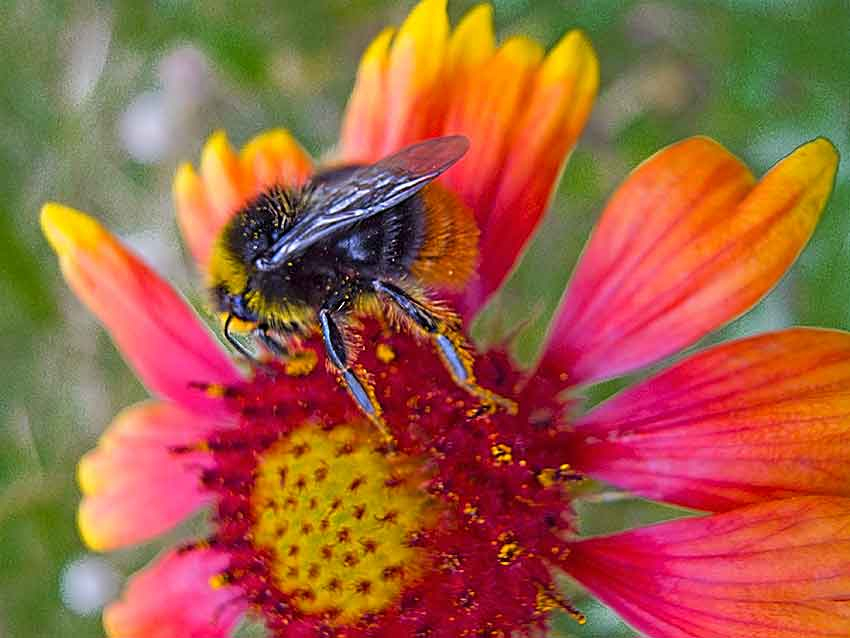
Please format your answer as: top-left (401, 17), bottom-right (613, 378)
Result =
top-left (191, 320), bottom-right (578, 638)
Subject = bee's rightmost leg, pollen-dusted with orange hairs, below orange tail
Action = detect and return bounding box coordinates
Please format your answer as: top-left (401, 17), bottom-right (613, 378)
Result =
top-left (372, 280), bottom-right (517, 414)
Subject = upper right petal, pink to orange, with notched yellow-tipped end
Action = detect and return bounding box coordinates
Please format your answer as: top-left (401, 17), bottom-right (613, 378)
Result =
top-left (541, 138), bottom-right (838, 384)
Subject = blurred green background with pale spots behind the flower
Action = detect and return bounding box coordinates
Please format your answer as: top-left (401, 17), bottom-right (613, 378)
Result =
top-left (0, 0), bottom-right (850, 638)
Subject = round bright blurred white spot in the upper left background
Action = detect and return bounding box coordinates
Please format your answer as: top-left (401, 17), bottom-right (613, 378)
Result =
top-left (118, 91), bottom-right (171, 164)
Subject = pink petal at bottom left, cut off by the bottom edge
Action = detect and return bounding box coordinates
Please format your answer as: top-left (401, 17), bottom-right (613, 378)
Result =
top-left (103, 550), bottom-right (245, 638)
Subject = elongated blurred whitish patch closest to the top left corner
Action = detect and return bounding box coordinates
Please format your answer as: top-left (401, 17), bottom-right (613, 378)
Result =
top-left (63, 12), bottom-right (112, 108)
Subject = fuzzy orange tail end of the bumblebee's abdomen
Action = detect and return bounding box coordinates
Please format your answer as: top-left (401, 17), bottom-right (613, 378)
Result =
top-left (410, 183), bottom-right (478, 290)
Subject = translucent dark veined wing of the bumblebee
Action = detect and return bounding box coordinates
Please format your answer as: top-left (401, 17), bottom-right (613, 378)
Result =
top-left (254, 135), bottom-right (469, 270)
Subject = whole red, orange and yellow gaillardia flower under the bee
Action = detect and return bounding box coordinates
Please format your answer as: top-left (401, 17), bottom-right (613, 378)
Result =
top-left (42, 0), bottom-right (850, 638)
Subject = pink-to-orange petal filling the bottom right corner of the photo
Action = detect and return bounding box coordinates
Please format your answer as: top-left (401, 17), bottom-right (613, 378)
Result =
top-left (563, 496), bottom-right (850, 638)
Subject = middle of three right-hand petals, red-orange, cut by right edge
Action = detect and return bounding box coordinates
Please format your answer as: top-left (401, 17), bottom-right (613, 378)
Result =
top-left (569, 328), bottom-right (850, 511)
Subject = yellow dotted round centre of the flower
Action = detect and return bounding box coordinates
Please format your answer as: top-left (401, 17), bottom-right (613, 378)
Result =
top-left (251, 424), bottom-right (436, 625)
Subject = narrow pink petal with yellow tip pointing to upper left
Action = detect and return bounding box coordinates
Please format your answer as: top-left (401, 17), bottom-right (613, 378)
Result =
top-left (41, 204), bottom-right (240, 413)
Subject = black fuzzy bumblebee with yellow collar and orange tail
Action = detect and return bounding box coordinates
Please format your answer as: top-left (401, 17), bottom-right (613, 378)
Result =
top-left (209, 136), bottom-right (510, 433)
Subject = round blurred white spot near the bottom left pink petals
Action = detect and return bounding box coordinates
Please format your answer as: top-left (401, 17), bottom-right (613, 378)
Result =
top-left (59, 554), bottom-right (121, 616)
